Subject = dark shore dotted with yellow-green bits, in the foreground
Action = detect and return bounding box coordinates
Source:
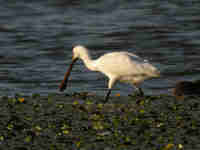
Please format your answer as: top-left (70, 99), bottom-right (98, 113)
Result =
top-left (0, 93), bottom-right (200, 150)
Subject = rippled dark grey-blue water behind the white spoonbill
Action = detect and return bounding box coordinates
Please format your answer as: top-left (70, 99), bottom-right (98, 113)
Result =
top-left (0, 0), bottom-right (200, 95)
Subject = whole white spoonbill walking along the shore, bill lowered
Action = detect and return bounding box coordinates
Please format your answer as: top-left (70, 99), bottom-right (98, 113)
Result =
top-left (59, 45), bottom-right (160, 102)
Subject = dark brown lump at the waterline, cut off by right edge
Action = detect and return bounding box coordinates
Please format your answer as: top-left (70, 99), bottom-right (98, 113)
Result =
top-left (172, 80), bottom-right (200, 99)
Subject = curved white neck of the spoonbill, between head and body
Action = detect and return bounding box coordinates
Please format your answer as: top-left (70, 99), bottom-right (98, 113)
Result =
top-left (81, 53), bottom-right (96, 71)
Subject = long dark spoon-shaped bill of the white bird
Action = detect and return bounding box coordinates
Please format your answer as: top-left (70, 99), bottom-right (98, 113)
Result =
top-left (59, 59), bottom-right (77, 92)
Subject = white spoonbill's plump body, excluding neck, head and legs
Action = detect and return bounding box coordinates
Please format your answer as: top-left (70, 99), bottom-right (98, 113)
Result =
top-left (95, 52), bottom-right (159, 85)
